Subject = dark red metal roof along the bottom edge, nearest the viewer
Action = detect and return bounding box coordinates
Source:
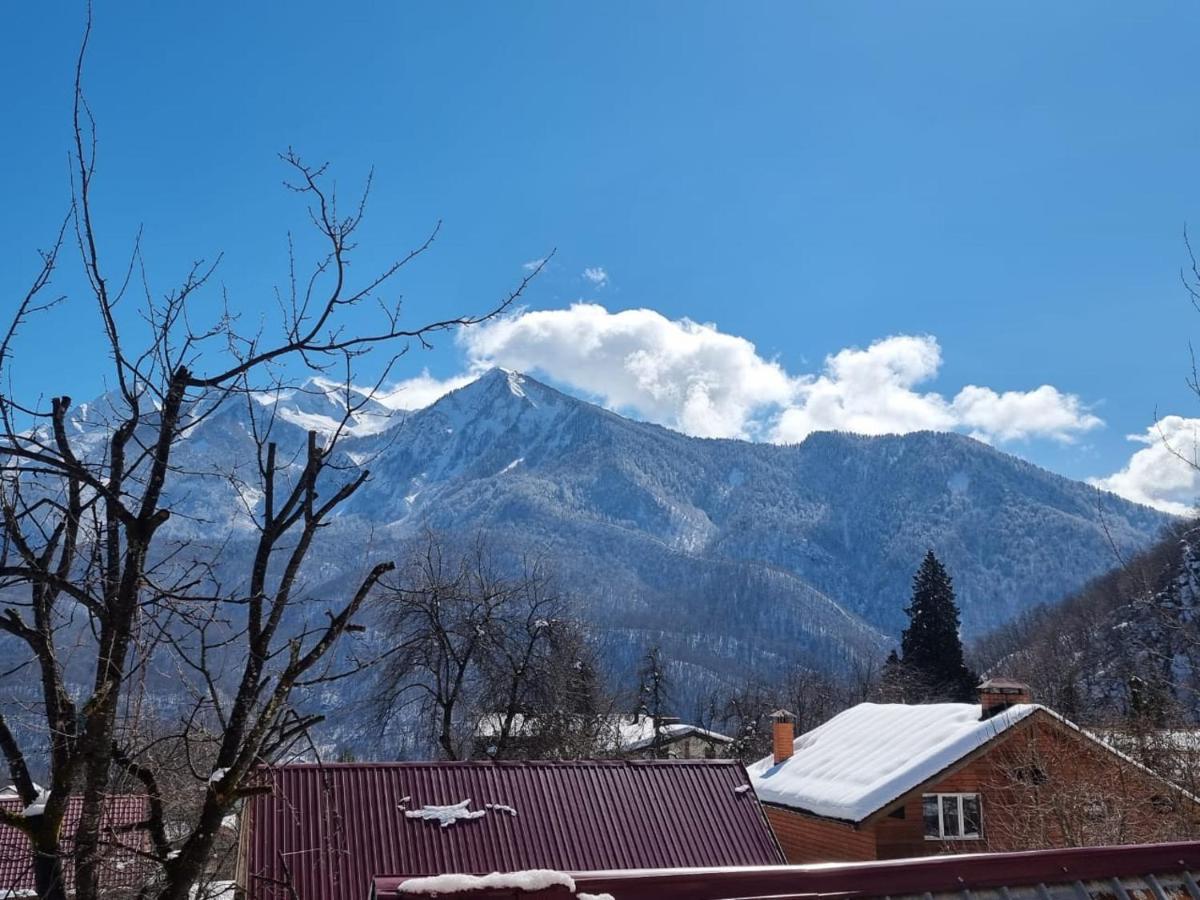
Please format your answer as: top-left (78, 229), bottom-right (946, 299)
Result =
top-left (372, 842), bottom-right (1200, 900)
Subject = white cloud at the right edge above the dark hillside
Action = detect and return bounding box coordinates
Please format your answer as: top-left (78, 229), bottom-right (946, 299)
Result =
top-left (1088, 415), bottom-right (1200, 516)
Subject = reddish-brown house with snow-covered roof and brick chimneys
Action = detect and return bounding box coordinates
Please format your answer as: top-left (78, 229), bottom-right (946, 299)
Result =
top-left (749, 679), bottom-right (1200, 863)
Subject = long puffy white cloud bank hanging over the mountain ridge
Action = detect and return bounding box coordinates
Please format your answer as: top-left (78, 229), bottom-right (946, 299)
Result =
top-left (448, 302), bottom-right (1102, 443)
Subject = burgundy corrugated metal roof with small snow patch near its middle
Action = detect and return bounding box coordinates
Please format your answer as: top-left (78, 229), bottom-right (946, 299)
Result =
top-left (242, 760), bottom-right (782, 900)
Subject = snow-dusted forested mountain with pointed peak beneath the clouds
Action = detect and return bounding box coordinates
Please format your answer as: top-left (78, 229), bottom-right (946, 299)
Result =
top-left (98, 370), bottom-right (1168, 672)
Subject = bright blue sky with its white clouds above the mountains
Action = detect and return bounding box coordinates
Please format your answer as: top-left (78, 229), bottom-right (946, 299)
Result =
top-left (0, 0), bottom-right (1200, 505)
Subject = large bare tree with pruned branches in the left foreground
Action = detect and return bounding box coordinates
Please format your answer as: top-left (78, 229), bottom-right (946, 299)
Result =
top-left (0, 18), bottom-right (544, 900)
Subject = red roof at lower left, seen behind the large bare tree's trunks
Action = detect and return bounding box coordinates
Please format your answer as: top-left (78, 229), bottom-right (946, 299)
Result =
top-left (0, 794), bottom-right (150, 896)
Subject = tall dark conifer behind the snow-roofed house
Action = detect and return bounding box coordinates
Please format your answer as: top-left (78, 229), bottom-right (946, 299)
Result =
top-left (900, 551), bottom-right (978, 703)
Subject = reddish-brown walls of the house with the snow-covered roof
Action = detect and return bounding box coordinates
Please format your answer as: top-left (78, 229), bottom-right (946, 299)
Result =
top-left (767, 719), bottom-right (1200, 863)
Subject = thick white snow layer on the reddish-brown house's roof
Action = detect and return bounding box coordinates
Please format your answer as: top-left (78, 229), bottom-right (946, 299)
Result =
top-left (748, 703), bottom-right (1043, 822)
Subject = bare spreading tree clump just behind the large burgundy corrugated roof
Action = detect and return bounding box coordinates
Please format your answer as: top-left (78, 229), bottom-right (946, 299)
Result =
top-left (379, 533), bottom-right (594, 760)
